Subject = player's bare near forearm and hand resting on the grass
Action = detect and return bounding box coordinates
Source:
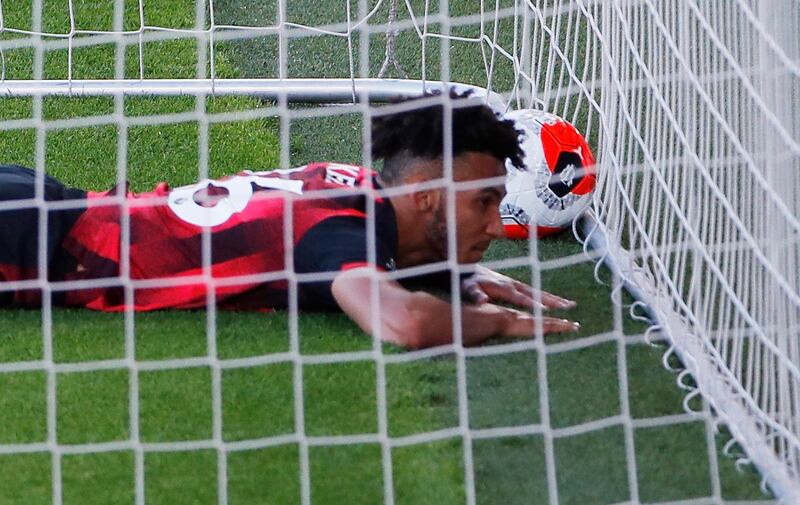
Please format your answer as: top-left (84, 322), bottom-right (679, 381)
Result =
top-left (331, 267), bottom-right (578, 349)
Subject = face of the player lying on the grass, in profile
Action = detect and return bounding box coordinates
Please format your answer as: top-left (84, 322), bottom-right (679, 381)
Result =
top-left (427, 152), bottom-right (506, 263)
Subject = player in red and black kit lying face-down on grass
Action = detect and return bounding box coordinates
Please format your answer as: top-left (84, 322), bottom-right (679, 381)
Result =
top-left (0, 93), bottom-right (577, 348)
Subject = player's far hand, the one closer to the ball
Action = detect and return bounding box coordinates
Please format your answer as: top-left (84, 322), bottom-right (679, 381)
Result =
top-left (461, 265), bottom-right (576, 312)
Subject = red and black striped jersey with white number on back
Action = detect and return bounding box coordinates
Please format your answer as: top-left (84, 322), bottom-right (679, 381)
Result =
top-left (49, 163), bottom-right (397, 311)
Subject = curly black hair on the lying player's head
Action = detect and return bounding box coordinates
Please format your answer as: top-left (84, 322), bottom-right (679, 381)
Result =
top-left (372, 88), bottom-right (525, 185)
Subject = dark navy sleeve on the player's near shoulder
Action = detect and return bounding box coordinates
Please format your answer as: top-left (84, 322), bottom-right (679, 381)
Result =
top-left (294, 216), bottom-right (394, 310)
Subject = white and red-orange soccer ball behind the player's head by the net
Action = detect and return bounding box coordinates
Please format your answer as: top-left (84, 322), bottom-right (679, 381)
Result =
top-left (500, 109), bottom-right (597, 239)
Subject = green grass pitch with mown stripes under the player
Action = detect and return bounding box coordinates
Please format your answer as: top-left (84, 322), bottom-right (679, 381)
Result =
top-left (0, 0), bottom-right (776, 505)
